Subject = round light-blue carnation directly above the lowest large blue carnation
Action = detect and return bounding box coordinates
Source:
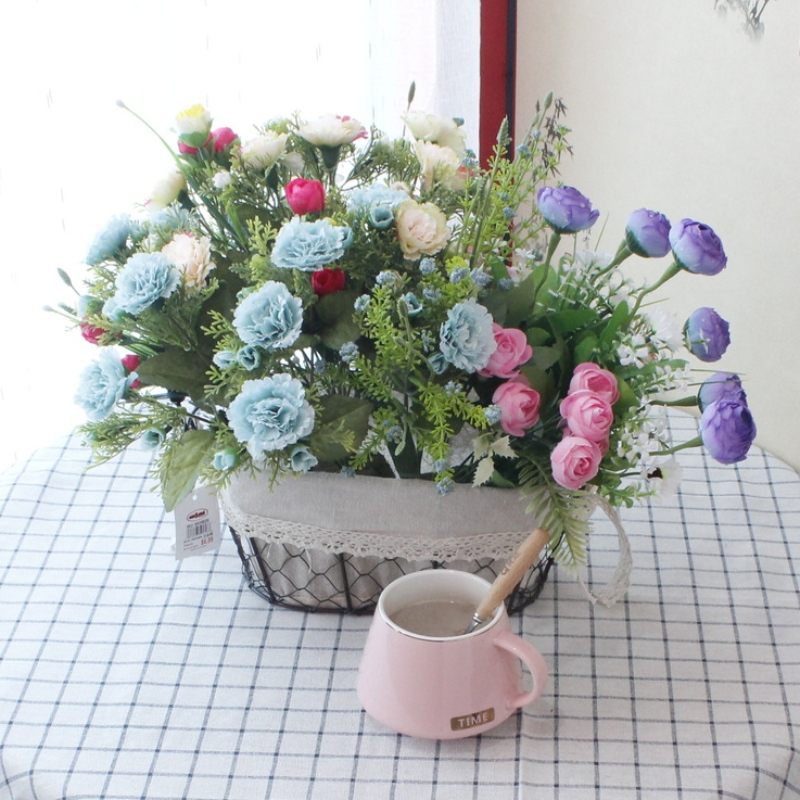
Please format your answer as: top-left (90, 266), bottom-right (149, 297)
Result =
top-left (233, 281), bottom-right (303, 350)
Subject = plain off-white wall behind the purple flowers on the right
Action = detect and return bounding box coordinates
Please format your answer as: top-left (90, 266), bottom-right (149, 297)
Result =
top-left (517, 0), bottom-right (800, 468)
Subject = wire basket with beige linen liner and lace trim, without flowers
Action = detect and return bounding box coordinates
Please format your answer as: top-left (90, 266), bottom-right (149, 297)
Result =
top-left (222, 473), bottom-right (553, 613)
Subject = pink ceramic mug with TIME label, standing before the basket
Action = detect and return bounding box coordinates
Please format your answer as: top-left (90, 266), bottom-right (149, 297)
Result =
top-left (357, 569), bottom-right (547, 739)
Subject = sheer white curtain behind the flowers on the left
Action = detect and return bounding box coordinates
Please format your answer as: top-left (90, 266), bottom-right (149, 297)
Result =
top-left (0, 0), bottom-right (480, 469)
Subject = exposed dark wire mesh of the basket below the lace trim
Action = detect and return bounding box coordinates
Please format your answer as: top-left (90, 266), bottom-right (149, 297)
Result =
top-left (229, 528), bottom-right (553, 614)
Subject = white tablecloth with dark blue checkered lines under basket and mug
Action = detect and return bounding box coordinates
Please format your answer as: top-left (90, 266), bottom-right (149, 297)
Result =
top-left (0, 416), bottom-right (800, 800)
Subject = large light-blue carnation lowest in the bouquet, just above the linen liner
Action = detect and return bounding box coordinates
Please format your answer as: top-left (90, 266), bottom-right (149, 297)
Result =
top-left (228, 373), bottom-right (314, 461)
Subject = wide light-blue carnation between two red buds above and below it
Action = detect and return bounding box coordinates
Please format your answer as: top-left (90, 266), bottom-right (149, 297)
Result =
top-left (272, 217), bottom-right (353, 272)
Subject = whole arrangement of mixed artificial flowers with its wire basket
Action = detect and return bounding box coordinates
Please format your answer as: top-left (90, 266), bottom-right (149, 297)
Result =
top-left (54, 92), bottom-right (755, 608)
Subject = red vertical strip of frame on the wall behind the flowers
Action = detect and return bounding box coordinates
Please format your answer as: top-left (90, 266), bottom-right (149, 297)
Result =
top-left (479, 0), bottom-right (514, 164)
